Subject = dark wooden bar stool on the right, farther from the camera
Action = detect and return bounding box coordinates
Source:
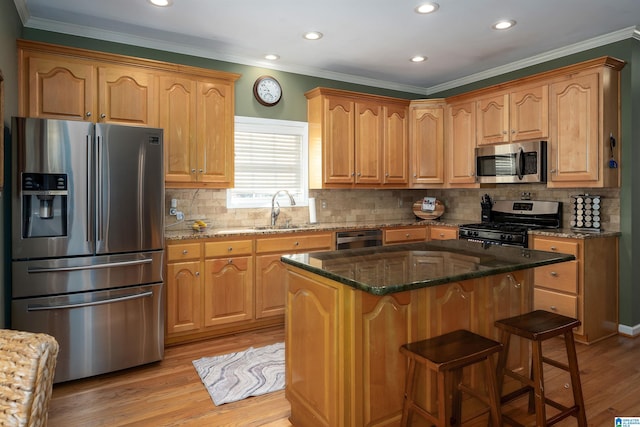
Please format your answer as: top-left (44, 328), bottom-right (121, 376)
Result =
top-left (495, 310), bottom-right (587, 427)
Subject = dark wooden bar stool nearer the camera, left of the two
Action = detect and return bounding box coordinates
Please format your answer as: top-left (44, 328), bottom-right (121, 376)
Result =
top-left (400, 330), bottom-right (502, 427)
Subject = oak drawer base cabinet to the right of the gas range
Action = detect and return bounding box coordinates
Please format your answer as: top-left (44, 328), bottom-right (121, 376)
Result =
top-left (531, 236), bottom-right (618, 344)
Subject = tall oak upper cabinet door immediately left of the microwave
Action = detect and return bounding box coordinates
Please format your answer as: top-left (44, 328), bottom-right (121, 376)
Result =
top-left (446, 101), bottom-right (476, 187)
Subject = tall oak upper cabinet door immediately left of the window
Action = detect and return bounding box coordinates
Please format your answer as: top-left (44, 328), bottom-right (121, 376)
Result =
top-left (198, 81), bottom-right (235, 188)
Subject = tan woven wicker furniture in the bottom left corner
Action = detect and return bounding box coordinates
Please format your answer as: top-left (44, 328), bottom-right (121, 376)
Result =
top-left (0, 329), bottom-right (58, 426)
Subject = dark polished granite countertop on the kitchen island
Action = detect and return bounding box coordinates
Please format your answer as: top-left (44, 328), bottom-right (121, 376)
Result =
top-left (282, 240), bottom-right (575, 295)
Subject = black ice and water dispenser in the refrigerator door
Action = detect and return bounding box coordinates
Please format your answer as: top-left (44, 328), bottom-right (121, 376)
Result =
top-left (20, 172), bottom-right (69, 238)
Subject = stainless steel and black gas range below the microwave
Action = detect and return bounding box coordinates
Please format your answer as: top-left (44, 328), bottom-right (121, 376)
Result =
top-left (458, 200), bottom-right (562, 247)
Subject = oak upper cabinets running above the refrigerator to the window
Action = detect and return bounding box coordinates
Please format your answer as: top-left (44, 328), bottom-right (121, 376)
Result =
top-left (18, 40), bottom-right (240, 188)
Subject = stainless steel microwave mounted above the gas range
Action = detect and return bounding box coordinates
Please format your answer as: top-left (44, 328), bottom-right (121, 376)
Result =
top-left (476, 141), bottom-right (547, 183)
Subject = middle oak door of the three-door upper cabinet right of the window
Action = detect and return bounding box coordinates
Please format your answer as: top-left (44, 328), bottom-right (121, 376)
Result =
top-left (355, 102), bottom-right (384, 184)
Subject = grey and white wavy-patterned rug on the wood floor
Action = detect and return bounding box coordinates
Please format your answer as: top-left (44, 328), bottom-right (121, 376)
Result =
top-left (193, 343), bottom-right (284, 406)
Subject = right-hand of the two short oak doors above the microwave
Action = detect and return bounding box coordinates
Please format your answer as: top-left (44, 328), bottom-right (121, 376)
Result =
top-left (509, 85), bottom-right (549, 142)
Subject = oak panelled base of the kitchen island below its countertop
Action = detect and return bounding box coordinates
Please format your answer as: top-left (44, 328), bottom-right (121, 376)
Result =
top-left (285, 266), bottom-right (533, 427)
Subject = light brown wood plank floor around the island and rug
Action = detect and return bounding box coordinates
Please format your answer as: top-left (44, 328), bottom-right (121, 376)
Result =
top-left (49, 328), bottom-right (640, 427)
